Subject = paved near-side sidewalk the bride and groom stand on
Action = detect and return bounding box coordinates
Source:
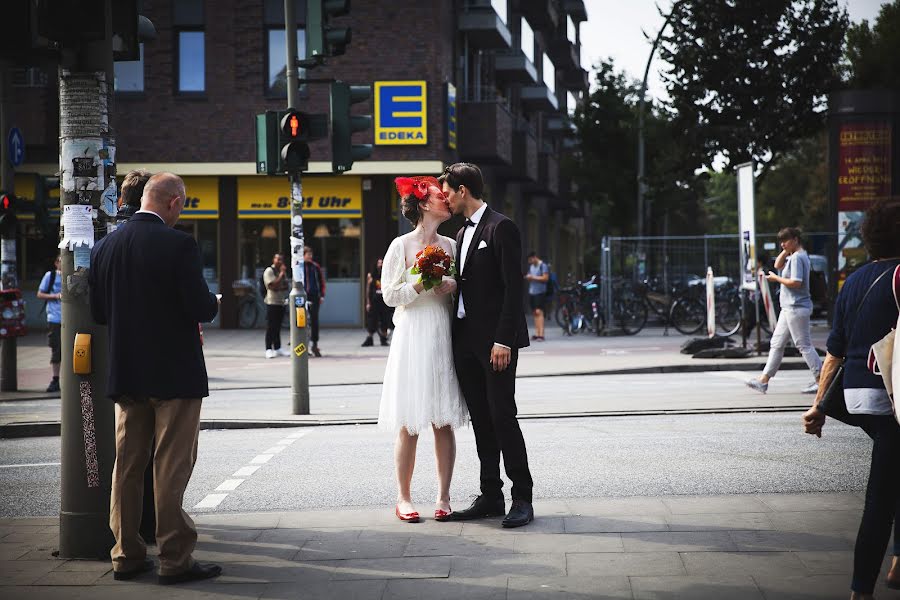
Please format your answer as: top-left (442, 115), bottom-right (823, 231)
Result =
top-left (0, 493), bottom-right (895, 600)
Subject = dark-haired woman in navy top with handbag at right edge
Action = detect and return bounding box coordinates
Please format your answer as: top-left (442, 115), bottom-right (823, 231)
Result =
top-left (803, 200), bottom-right (900, 600)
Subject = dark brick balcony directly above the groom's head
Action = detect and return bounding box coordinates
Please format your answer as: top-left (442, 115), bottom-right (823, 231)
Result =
top-left (457, 88), bottom-right (513, 166)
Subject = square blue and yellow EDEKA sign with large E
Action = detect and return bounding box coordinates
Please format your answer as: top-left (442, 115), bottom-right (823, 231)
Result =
top-left (375, 81), bottom-right (428, 146)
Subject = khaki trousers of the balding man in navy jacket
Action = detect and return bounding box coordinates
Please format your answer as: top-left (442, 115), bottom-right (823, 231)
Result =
top-left (109, 397), bottom-right (201, 575)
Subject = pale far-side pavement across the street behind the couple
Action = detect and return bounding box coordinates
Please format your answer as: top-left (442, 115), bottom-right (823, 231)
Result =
top-left (0, 324), bottom-right (828, 402)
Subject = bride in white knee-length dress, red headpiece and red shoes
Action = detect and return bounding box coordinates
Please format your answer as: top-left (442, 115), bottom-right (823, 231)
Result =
top-left (378, 177), bottom-right (468, 523)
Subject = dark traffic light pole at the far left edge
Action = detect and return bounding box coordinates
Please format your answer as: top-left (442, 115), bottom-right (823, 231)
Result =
top-left (0, 60), bottom-right (19, 392)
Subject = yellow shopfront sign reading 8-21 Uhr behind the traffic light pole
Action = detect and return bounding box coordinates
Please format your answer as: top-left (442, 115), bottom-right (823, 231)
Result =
top-left (238, 175), bottom-right (362, 219)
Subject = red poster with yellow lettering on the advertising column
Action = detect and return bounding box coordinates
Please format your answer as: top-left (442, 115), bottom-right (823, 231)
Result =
top-left (838, 121), bottom-right (892, 211)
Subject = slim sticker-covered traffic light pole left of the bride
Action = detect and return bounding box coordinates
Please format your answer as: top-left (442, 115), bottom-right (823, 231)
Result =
top-left (284, 0), bottom-right (309, 415)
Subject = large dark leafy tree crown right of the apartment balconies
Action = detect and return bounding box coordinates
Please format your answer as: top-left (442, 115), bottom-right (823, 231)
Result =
top-left (660, 0), bottom-right (848, 167)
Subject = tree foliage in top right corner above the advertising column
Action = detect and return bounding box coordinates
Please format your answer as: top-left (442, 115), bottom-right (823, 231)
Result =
top-left (846, 0), bottom-right (900, 90)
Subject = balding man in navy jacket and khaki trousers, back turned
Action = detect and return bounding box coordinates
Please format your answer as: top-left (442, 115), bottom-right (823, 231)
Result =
top-left (88, 173), bottom-right (222, 584)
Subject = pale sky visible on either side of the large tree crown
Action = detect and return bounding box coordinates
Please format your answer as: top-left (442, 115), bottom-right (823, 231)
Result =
top-left (581, 0), bottom-right (884, 98)
